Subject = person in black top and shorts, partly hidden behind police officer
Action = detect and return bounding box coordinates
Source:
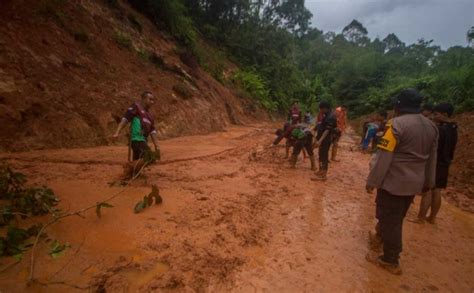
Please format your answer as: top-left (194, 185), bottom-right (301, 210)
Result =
top-left (417, 103), bottom-right (458, 224)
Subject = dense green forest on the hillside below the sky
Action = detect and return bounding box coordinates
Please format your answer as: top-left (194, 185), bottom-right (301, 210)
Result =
top-left (124, 0), bottom-right (474, 115)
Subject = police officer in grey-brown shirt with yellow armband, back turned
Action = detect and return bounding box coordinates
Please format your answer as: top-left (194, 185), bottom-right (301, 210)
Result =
top-left (366, 89), bottom-right (438, 274)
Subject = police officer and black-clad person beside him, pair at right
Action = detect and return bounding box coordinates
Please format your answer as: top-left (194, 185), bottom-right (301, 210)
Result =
top-left (366, 89), bottom-right (457, 274)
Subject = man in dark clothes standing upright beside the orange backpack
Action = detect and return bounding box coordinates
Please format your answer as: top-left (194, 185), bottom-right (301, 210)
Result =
top-left (311, 102), bottom-right (337, 181)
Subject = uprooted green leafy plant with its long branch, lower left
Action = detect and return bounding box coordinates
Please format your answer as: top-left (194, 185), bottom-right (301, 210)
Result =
top-left (0, 160), bottom-right (162, 285)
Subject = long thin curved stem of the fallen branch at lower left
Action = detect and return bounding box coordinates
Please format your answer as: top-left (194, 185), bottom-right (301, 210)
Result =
top-left (27, 162), bottom-right (148, 289)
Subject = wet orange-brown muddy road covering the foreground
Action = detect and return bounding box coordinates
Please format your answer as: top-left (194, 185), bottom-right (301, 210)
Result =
top-left (0, 125), bottom-right (474, 292)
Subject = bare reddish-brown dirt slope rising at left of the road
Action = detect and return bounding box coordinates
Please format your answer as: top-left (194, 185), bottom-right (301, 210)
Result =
top-left (0, 0), bottom-right (264, 151)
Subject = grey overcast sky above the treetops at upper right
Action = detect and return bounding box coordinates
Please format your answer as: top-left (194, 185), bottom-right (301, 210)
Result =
top-left (306, 0), bottom-right (474, 49)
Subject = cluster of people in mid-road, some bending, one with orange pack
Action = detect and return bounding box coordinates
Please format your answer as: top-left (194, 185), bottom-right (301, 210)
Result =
top-left (271, 101), bottom-right (347, 181)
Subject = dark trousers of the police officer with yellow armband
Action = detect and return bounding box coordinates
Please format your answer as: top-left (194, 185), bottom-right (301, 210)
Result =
top-left (375, 189), bottom-right (415, 264)
